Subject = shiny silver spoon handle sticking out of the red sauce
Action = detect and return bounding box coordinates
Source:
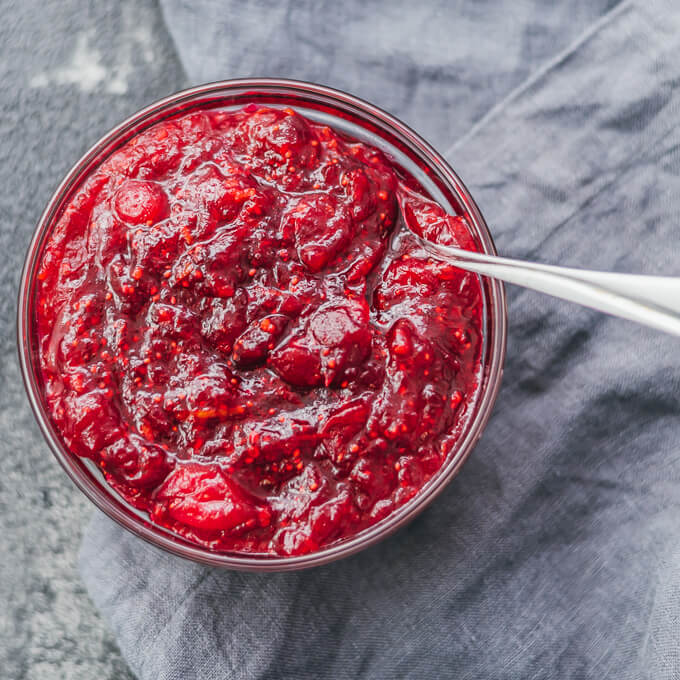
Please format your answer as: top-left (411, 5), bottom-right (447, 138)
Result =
top-left (419, 239), bottom-right (680, 336)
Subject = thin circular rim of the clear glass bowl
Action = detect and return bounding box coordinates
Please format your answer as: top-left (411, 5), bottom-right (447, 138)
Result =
top-left (17, 78), bottom-right (507, 571)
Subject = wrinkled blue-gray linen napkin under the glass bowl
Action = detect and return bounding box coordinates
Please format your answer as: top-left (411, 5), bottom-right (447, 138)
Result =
top-left (81, 0), bottom-right (680, 680)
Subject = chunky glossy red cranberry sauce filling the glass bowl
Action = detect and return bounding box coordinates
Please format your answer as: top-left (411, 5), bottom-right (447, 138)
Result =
top-left (35, 105), bottom-right (482, 555)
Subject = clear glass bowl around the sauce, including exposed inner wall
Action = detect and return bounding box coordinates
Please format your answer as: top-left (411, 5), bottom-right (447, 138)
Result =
top-left (17, 78), bottom-right (507, 571)
